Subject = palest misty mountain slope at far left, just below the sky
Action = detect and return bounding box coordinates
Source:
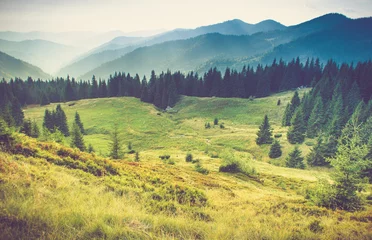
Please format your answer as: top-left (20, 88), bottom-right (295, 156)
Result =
top-left (0, 39), bottom-right (80, 73)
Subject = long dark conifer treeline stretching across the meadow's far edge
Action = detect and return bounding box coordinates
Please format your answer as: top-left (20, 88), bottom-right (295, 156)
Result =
top-left (0, 58), bottom-right (372, 126)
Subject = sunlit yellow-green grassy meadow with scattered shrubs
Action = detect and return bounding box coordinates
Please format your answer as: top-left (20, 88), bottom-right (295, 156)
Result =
top-left (0, 90), bottom-right (372, 239)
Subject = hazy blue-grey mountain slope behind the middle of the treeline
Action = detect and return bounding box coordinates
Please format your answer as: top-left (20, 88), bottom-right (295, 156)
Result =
top-left (83, 33), bottom-right (271, 79)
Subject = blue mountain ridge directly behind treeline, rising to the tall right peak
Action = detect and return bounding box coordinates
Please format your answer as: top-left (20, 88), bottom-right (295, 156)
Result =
top-left (82, 14), bottom-right (372, 79)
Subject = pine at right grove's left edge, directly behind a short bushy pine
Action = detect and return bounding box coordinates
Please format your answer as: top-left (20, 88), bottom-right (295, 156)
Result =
top-left (287, 108), bottom-right (306, 144)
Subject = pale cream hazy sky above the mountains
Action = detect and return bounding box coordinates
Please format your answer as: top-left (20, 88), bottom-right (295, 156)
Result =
top-left (0, 0), bottom-right (372, 32)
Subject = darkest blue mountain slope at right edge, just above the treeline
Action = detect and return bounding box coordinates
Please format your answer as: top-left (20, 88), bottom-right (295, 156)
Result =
top-left (264, 18), bottom-right (372, 63)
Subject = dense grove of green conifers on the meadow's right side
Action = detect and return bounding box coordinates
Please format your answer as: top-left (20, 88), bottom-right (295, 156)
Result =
top-left (282, 61), bottom-right (372, 170)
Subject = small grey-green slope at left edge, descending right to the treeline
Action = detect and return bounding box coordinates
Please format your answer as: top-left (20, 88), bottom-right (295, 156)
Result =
top-left (0, 52), bottom-right (50, 80)
